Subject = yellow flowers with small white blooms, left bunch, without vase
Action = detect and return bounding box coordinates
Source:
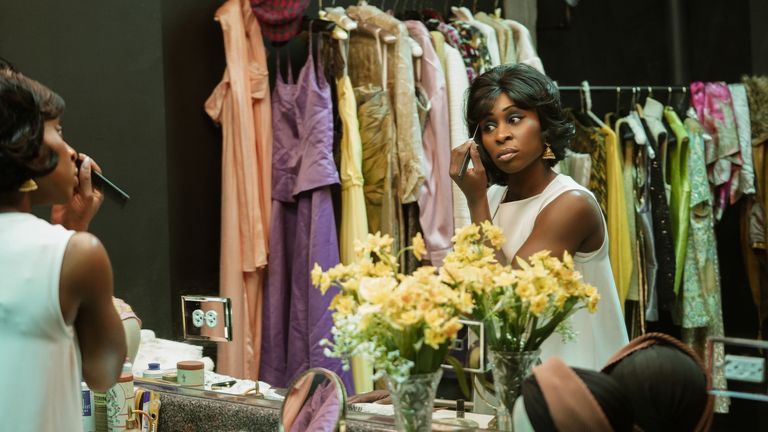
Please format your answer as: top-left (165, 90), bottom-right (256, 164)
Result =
top-left (312, 233), bottom-right (473, 381)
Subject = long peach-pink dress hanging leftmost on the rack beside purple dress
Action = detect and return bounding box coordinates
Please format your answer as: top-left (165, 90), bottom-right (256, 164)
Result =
top-left (205, 0), bottom-right (272, 380)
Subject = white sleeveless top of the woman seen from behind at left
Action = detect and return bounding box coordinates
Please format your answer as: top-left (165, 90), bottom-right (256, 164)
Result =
top-left (0, 213), bottom-right (83, 432)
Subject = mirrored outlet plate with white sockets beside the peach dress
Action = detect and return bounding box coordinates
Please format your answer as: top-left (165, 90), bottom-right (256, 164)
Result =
top-left (181, 295), bottom-right (232, 342)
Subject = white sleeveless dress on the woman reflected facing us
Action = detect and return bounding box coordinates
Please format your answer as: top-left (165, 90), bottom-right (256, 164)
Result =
top-left (488, 174), bottom-right (629, 370)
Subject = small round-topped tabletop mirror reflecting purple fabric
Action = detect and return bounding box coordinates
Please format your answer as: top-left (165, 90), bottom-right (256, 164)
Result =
top-left (280, 368), bottom-right (347, 432)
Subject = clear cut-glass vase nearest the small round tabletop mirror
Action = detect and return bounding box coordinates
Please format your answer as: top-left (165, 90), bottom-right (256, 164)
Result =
top-left (387, 369), bottom-right (443, 432)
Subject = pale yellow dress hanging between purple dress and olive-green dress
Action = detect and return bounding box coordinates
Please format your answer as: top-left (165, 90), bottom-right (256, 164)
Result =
top-left (336, 48), bottom-right (373, 393)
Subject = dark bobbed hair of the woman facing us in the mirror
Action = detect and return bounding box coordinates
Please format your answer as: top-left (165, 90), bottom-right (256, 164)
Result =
top-left (466, 64), bottom-right (575, 185)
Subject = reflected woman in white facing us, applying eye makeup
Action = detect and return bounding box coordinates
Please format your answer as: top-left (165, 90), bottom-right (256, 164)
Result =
top-left (450, 64), bottom-right (628, 369)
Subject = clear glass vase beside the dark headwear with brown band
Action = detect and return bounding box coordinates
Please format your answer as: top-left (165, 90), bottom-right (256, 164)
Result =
top-left (488, 349), bottom-right (541, 432)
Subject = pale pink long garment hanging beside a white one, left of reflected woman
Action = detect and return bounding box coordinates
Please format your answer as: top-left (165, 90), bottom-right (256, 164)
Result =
top-left (405, 21), bottom-right (453, 266)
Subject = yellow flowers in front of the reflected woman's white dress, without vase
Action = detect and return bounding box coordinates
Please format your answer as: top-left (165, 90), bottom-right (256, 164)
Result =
top-left (440, 221), bottom-right (600, 352)
